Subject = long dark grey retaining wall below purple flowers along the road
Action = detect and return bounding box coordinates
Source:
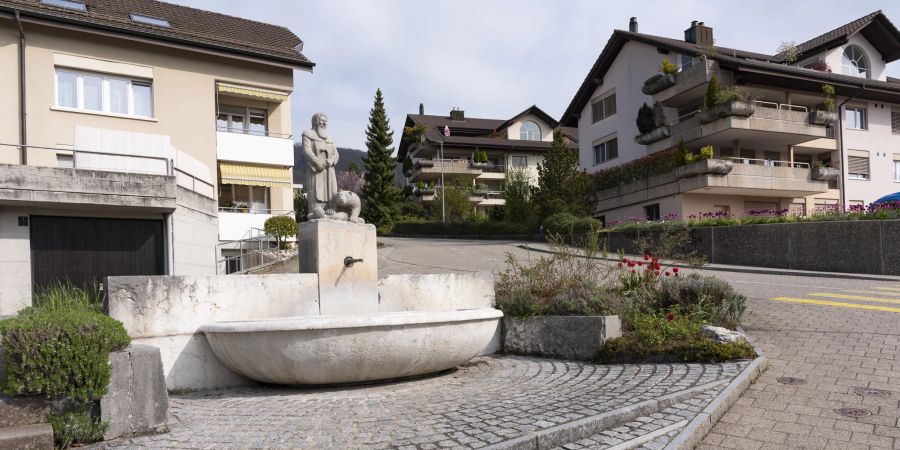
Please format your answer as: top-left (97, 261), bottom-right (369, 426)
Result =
top-left (601, 220), bottom-right (900, 275)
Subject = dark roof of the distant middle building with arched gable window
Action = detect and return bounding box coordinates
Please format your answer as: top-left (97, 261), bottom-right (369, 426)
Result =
top-left (397, 110), bottom-right (578, 160)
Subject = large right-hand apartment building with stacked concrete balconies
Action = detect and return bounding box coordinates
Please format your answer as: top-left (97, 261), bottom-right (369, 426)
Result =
top-left (560, 11), bottom-right (900, 222)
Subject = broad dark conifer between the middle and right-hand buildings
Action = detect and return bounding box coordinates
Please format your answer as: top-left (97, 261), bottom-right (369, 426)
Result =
top-left (534, 130), bottom-right (591, 217)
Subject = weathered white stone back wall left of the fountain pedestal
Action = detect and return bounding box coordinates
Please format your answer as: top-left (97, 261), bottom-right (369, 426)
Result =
top-left (106, 272), bottom-right (320, 338)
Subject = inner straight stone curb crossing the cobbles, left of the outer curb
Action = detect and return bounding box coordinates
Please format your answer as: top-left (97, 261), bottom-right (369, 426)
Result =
top-left (484, 381), bottom-right (725, 450)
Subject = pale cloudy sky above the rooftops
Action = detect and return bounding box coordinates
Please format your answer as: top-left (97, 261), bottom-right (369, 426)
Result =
top-left (176, 0), bottom-right (900, 149)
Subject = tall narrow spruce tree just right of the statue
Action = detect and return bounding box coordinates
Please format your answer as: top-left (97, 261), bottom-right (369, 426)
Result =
top-left (361, 89), bottom-right (399, 227)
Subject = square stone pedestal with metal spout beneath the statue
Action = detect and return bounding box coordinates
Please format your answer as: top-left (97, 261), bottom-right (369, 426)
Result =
top-left (297, 219), bottom-right (378, 315)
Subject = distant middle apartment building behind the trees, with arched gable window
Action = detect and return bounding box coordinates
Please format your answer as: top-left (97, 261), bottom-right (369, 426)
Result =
top-left (398, 105), bottom-right (575, 214)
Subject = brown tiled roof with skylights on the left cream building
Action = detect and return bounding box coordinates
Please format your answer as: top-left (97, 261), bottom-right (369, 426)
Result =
top-left (0, 0), bottom-right (315, 68)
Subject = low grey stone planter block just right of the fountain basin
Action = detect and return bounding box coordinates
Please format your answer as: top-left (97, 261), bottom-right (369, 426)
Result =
top-left (503, 316), bottom-right (622, 360)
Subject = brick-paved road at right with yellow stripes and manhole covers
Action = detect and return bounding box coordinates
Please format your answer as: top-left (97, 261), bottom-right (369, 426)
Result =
top-left (701, 281), bottom-right (900, 450)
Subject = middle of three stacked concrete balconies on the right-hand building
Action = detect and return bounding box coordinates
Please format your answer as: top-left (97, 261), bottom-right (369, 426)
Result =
top-left (647, 101), bottom-right (832, 153)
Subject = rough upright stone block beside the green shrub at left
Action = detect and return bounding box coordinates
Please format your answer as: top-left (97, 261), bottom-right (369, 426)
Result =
top-left (100, 345), bottom-right (169, 440)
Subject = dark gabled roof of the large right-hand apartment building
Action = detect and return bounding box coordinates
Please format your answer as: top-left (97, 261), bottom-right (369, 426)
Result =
top-left (559, 11), bottom-right (900, 126)
